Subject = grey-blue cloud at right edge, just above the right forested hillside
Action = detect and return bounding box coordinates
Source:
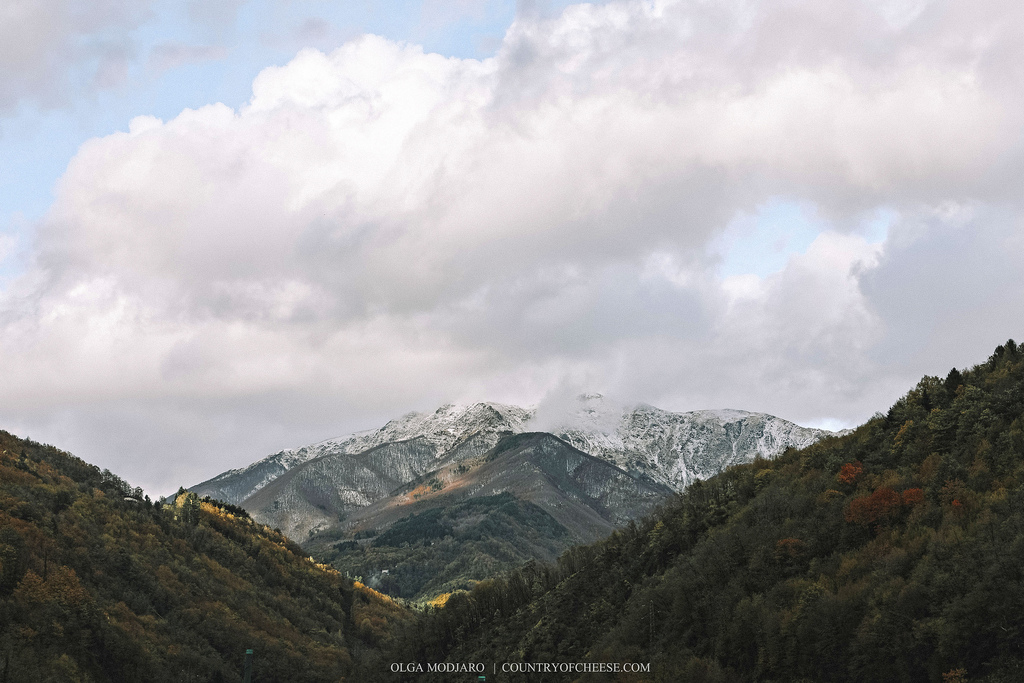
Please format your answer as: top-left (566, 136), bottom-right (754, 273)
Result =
top-left (861, 202), bottom-right (1024, 374)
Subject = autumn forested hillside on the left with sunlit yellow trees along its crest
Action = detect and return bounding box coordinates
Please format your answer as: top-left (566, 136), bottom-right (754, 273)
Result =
top-left (0, 432), bottom-right (408, 683)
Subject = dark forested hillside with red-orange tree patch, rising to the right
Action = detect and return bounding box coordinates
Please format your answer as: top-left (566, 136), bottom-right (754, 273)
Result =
top-left (391, 341), bottom-right (1024, 683)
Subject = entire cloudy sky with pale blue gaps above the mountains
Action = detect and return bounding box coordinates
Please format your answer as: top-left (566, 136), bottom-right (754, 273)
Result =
top-left (0, 0), bottom-right (1024, 495)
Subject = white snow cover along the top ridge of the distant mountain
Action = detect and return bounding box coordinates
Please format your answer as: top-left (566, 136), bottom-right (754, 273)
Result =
top-left (194, 394), bottom-right (833, 502)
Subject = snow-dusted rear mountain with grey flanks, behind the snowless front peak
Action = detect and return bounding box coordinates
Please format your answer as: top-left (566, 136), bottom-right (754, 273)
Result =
top-left (189, 395), bottom-right (830, 542)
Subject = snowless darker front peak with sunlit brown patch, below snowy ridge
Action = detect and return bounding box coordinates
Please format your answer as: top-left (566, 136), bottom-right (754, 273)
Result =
top-left (306, 433), bottom-right (672, 600)
